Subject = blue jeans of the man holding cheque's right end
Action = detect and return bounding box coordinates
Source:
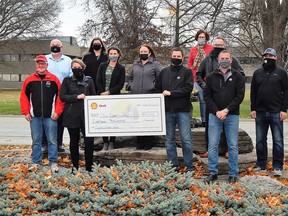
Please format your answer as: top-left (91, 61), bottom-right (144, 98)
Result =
top-left (165, 112), bottom-right (193, 171)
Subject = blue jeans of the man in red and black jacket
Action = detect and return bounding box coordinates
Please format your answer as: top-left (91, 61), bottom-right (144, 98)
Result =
top-left (30, 117), bottom-right (58, 164)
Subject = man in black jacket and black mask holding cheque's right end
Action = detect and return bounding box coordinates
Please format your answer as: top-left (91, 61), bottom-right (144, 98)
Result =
top-left (155, 48), bottom-right (194, 172)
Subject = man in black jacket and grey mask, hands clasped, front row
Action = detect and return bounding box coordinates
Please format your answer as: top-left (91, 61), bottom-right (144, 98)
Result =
top-left (204, 50), bottom-right (245, 183)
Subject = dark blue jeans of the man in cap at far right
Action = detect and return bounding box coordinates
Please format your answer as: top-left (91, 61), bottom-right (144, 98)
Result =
top-left (256, 112), bottom-right (284, 170)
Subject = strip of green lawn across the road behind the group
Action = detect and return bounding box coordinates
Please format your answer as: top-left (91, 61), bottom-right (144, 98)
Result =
top-left (0, 90), bottom-right (250, 118)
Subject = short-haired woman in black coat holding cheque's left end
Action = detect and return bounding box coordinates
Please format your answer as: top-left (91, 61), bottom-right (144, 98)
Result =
top-left (60, 59), bottom-right (96, 171)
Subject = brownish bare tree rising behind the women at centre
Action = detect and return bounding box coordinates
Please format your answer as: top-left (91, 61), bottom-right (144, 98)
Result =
top-left (81, 0), bottom-right (165, 59)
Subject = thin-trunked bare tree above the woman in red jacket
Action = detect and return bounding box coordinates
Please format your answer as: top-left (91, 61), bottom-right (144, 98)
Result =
top-left (161, 0), bottom-right (225, 46)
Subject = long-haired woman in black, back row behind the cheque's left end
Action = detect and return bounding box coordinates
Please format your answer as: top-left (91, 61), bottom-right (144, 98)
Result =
top-left (82, 37), bottom-right (108, 93)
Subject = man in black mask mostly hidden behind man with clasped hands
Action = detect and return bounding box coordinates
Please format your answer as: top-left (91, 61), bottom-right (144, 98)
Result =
top-left (196, 37), bottom-right (245, 158)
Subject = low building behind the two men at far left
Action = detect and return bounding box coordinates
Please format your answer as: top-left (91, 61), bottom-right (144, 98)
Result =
top-left (0, 36), bottom-right (87, 89)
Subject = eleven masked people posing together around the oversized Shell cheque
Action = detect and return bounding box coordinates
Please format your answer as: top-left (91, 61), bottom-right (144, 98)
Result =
top-left (20, 30), bottom-right (288, 183)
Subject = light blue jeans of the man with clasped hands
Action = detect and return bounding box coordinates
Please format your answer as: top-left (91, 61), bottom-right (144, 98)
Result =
top-left (208, 113), bottom-right (239, 177)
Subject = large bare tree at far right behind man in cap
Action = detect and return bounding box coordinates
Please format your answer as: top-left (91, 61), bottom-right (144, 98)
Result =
top-left (215, 0), bottom-right (288, 64)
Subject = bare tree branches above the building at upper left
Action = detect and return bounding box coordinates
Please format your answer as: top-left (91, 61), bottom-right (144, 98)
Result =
top-left (0, 0), bottom-right (60, 40)
